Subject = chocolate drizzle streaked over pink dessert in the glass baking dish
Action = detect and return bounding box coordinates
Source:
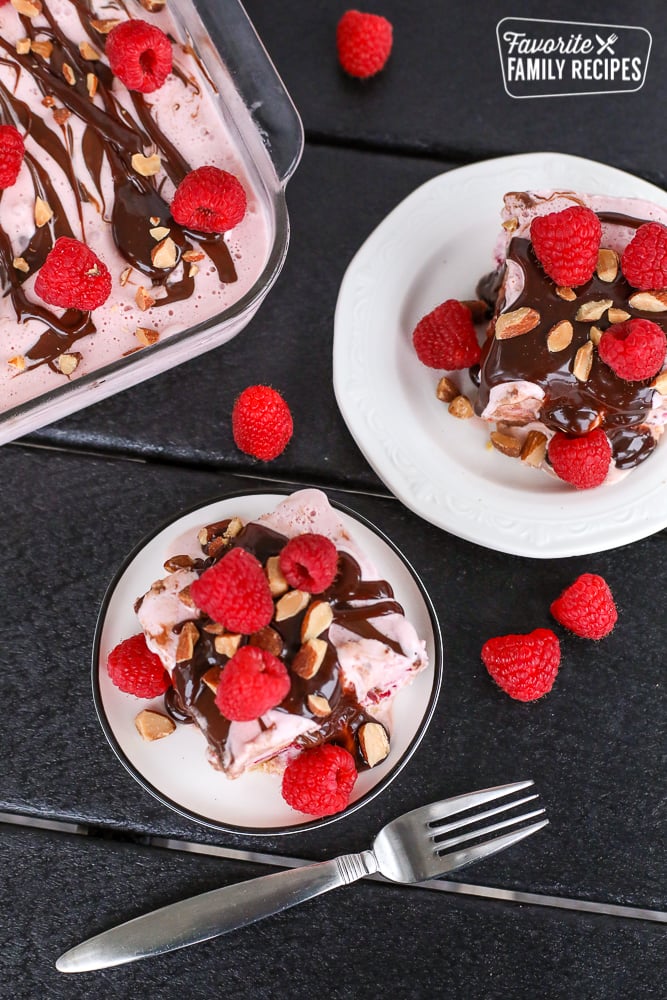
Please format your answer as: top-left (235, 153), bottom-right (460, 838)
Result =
top-left (0, 0), bottom-right (237, 377)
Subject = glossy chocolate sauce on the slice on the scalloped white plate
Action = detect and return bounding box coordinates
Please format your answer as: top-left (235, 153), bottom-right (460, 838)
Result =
top-left (476, 212), bottom-right (667, 469)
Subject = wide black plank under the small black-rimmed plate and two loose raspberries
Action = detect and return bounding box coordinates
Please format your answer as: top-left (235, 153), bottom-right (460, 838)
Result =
top-left (0, 446), bottom-right (667, 908)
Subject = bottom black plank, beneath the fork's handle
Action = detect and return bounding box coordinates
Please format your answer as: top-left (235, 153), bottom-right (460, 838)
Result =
top-left (0, 827), bottom-right (664, 1000)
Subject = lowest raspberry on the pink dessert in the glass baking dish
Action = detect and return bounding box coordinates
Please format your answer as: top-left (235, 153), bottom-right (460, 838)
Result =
top-left (35, 236), bottom-right (111, 310)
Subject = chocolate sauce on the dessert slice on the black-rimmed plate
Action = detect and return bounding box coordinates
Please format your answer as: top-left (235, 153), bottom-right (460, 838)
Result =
top-left (165, 522), bottom-right (410, 769)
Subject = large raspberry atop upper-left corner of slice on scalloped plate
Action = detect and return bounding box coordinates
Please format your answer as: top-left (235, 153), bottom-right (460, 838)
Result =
top-left (530, 205), bottom-right (602, 286)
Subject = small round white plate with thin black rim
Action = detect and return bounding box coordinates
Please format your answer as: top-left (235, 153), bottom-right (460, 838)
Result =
top-left (92, 491), bottom-right (442, 835)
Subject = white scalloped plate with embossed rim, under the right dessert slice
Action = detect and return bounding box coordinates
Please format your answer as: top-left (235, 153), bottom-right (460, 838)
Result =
top-left (333, 153), bottom-right (667, 558)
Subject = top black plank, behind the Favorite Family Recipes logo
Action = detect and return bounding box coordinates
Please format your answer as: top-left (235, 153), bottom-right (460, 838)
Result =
top-left (245, 0), bottom-right (667, 184)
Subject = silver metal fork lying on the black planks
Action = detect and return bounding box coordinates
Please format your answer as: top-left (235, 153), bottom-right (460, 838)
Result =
top-left (56, 781), bottom-right (549, 972)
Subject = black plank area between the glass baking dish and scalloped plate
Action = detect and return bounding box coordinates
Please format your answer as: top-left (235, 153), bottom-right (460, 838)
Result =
top-left (26, 148), bottom-right (446, 490)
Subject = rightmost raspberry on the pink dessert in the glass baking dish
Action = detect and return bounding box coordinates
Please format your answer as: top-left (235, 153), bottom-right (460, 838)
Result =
top-left (171, 166), bottom-right (248, 233)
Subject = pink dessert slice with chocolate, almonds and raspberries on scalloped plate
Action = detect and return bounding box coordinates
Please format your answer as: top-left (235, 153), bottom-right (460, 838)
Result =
top-left (476, 191), bottom-right (667, 489)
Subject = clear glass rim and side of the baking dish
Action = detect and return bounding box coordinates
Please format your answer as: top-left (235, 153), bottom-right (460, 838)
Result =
top-left (0, 0), bottom-right (303, 444)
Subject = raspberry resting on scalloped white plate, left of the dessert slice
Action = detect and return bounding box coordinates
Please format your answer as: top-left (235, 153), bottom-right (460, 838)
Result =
top-left (412, 299), bottom-right (481, 371)
